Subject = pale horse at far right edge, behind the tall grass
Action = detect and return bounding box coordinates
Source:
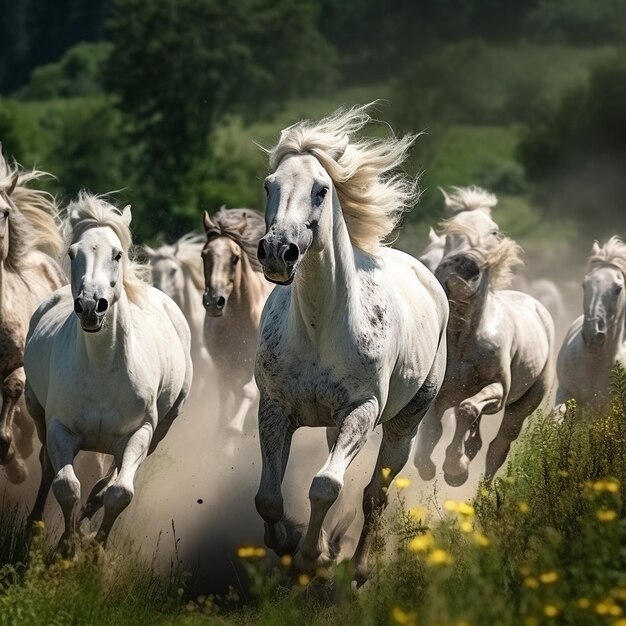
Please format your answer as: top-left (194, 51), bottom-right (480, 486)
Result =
top-left (556, 237), bottom-right (626, 412)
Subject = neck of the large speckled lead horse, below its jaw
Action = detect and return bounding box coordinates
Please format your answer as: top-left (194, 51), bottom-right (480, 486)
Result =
top-left (291, 195), bottom-right (359, 335)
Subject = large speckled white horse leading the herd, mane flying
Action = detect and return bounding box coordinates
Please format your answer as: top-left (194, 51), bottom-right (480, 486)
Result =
top-left (251, 107), bottom-right (448, 581)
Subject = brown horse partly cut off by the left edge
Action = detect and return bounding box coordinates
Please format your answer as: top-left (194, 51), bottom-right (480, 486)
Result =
top-left (0, 155), bottom-right (67, 484)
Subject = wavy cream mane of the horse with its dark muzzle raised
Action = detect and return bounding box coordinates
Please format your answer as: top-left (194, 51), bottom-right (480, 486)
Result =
top-left (440, 219), bottom-right (524, 289)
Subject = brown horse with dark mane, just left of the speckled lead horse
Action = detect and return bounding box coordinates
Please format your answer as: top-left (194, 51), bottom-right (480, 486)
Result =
top-left (202, 209), bottom-right (272, 445)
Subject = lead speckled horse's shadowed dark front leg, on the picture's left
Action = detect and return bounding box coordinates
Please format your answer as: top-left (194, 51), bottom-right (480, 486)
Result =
top-left (254, 393), bottom-right (300, 555)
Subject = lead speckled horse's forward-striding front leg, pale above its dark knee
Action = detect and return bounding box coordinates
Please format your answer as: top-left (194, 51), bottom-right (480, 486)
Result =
top-left (298, 398), bottom-right (379, 571)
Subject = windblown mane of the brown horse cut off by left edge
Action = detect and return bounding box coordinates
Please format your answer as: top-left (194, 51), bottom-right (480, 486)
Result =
top-left (0, 153), bottom-right (63, 272)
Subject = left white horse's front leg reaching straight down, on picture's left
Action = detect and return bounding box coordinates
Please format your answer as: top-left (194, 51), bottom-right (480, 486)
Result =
top-left (42, 421), bottom-right (81, 558)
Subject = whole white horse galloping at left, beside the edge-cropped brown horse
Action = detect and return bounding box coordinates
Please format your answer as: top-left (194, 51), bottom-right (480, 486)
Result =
top-left (24, 192), bottom-right (192, 554)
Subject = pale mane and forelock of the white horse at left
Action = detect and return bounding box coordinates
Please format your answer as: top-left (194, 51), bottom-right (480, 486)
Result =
top-left (64, 190), bottom-right (149, 304)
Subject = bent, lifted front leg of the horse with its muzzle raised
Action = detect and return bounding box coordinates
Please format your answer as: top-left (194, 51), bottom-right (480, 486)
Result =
top-left (443, 381), bottom-right (508, 487)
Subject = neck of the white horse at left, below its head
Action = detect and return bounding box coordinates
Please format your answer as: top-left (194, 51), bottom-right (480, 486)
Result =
top-left (76, 290), bottom-right (130, 368)
